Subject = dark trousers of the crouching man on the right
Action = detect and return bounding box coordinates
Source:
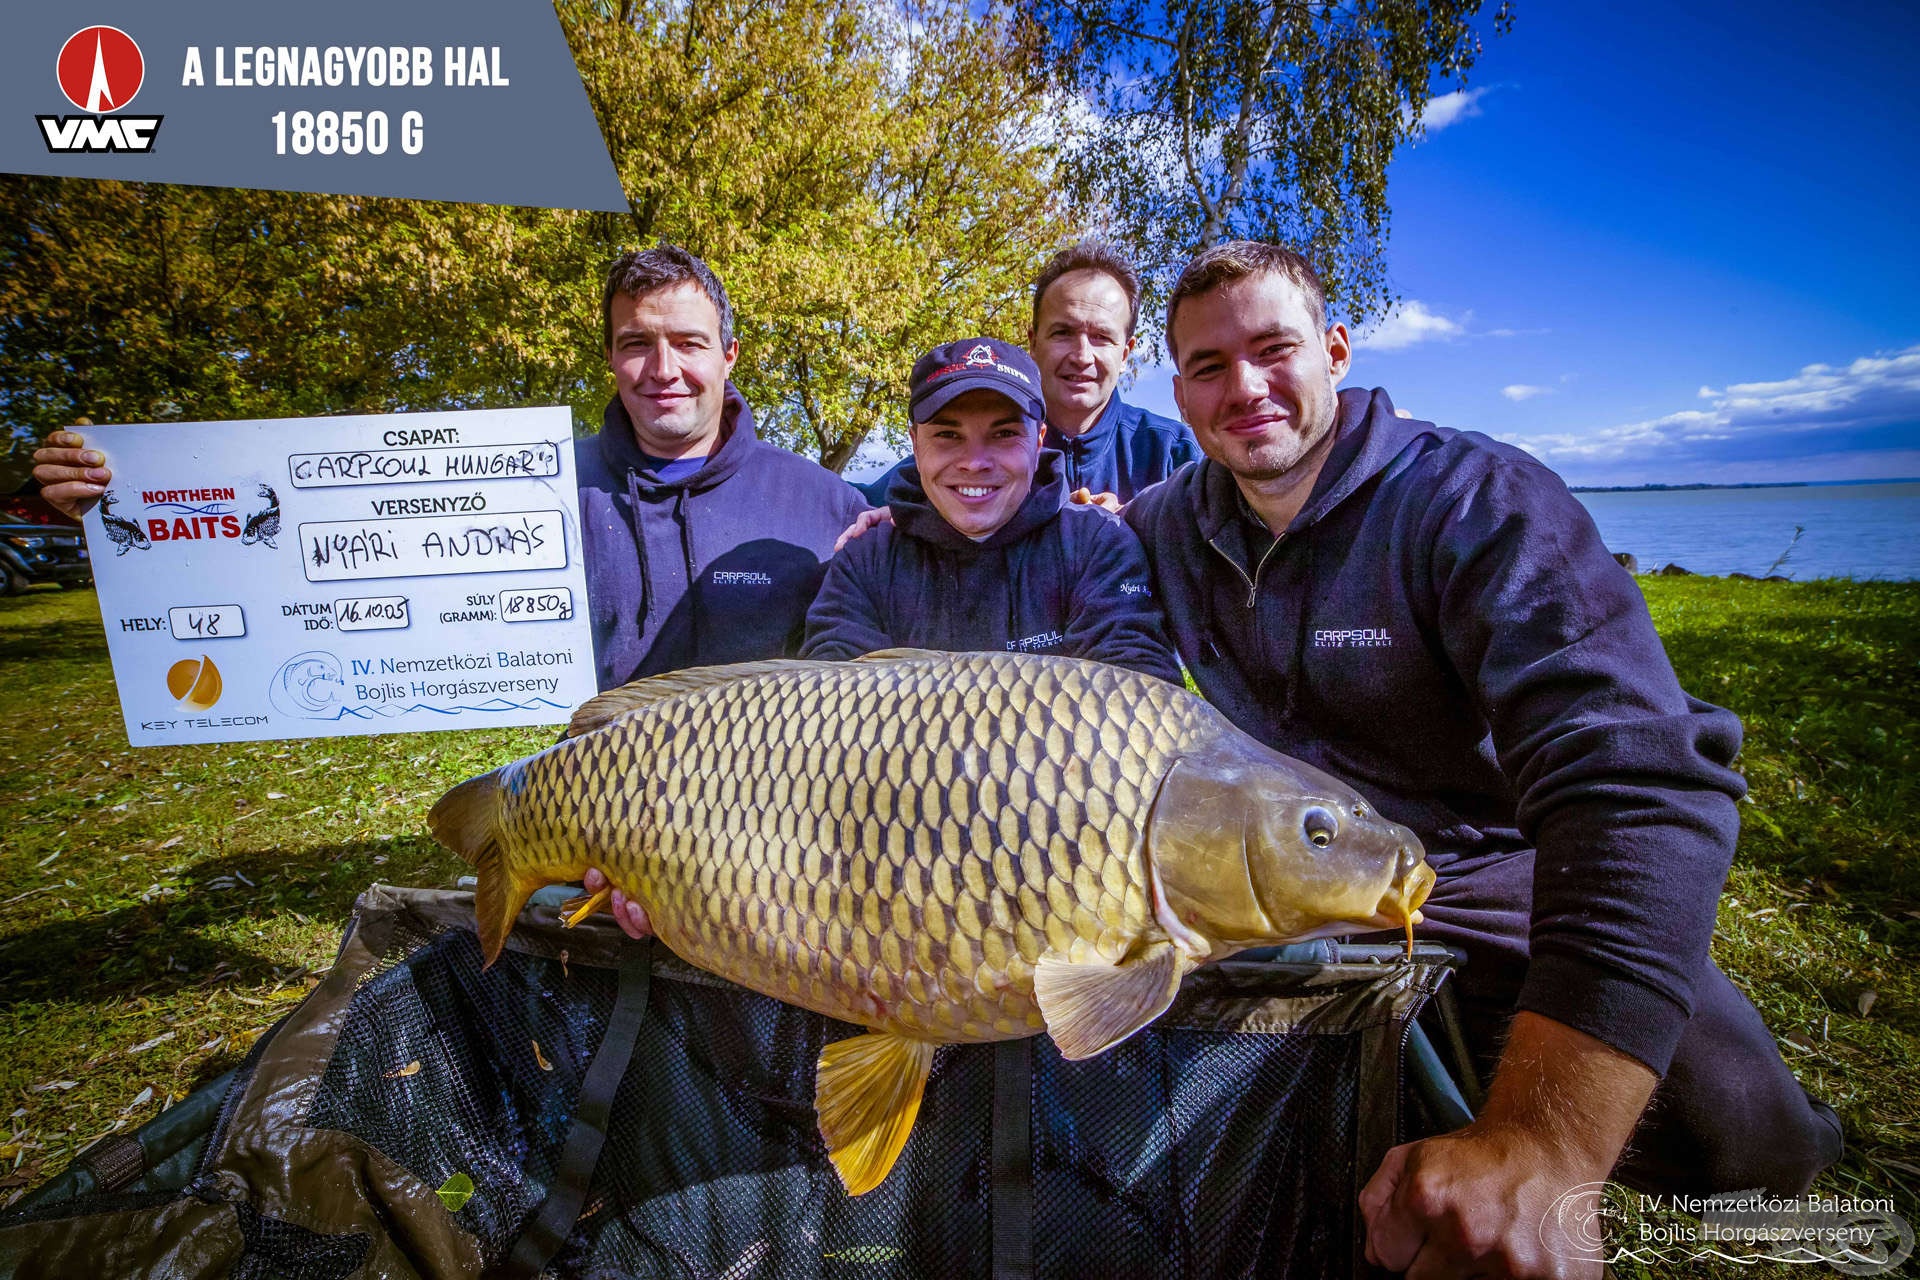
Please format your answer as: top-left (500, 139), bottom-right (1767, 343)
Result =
top-left (1419, 852), bottom-right (1841, 1196)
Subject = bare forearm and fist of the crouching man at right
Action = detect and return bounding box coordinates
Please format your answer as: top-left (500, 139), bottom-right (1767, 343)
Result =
top-left (1359, 1011), bottom-right (1655, 1280)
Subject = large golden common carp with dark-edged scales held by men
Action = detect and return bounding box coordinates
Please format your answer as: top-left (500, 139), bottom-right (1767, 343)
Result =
top-left (428, 651), bottom-right (1434, 1194)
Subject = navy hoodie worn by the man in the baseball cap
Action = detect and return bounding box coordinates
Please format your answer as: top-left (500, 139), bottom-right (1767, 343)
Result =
top-left (801, 449), bottom-right (1181, 683)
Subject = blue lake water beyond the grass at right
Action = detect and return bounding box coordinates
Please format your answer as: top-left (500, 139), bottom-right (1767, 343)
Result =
top-left (1576, 482), bottom-right (1920, 580)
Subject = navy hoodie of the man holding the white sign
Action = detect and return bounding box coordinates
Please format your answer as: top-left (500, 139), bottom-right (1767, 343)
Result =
top-left (574, 384), bottom-right (866, 689)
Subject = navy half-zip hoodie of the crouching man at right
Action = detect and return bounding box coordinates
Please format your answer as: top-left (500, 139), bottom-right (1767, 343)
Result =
top-left (1127, 390), bottom-right (1743, 1073)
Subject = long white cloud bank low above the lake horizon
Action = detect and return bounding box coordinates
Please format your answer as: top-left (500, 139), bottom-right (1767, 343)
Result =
top-left (1513, 345), bottom-right (1920, 470)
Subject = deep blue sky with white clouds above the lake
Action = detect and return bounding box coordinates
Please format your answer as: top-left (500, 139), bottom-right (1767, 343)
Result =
top-left (1127, 0), bottom-right (1920, 484)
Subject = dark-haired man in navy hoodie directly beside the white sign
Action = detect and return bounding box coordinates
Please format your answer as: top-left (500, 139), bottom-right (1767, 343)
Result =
top-left (574, 244), bottom-right (866, 689)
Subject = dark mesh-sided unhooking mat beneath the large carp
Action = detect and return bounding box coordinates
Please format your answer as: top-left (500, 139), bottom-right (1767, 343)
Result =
top-left (0, 885), bottom-right (1450, 1280)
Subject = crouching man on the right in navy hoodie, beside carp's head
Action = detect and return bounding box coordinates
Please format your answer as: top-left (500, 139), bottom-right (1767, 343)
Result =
top-left (1127, 242), bottom-right (1839, 1278)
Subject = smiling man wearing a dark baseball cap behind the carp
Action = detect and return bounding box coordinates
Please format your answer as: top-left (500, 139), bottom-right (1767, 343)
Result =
top-left (801, 338), bottom-right (1181, 681)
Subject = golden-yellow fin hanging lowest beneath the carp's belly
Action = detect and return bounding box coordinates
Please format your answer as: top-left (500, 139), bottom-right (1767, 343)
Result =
top-left (814, 1031), bottom-right (935, 1196)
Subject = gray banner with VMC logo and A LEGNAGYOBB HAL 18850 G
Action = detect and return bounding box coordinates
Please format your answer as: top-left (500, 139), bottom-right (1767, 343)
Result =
top-left (0, 0), bottom-right (626, 211)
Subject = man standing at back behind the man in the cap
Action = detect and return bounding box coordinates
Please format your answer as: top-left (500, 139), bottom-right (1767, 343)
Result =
top-left (866, 240), bottom-right (1200, 510)
